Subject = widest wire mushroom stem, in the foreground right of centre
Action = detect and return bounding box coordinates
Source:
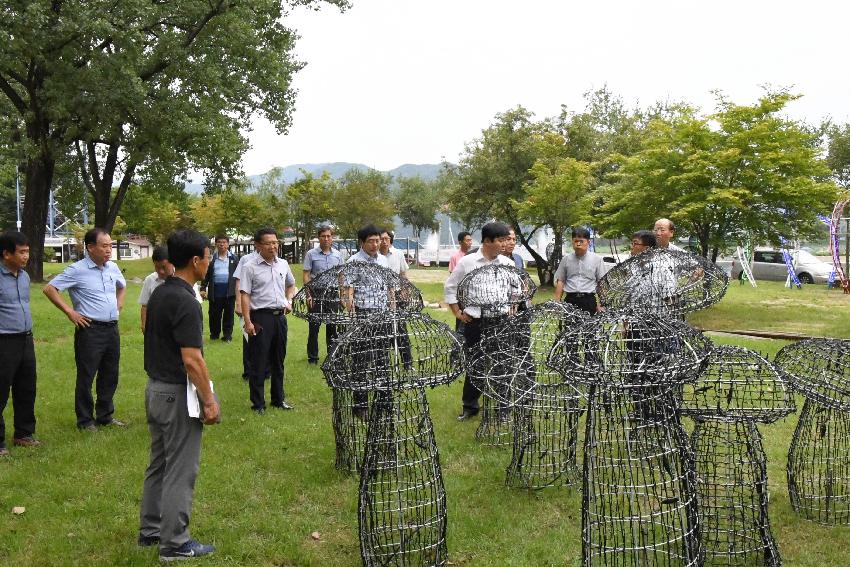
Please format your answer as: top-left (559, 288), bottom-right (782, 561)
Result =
top-left (582, 386), bottom-right (702, 567)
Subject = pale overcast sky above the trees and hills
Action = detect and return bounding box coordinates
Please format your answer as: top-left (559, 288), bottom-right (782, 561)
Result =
top-left (234, 0), bottom-right (850, 175)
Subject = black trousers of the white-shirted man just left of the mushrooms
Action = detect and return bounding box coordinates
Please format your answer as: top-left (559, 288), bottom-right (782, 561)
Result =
top-left (248, 311), bottom-right (288, 409)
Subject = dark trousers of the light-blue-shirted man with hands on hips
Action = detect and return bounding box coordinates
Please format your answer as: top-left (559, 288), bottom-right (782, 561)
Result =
top-left (74, 322), bottom-right (121, 427)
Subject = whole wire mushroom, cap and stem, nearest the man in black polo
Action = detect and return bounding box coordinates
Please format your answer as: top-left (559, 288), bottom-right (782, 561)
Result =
top-left (322, 311), bottom-right (465, 567)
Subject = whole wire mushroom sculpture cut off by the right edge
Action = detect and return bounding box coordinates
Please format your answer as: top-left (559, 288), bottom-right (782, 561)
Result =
top-left (774, 339), bottom-right (850, 525)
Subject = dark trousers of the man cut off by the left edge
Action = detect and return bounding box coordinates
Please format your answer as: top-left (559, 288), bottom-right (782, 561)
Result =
top-left (0, 334), bottom-right (36, 447)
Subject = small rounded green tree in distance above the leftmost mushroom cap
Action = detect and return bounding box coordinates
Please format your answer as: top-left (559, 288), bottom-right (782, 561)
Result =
top-left (333, 168), bottom-right (395, 247)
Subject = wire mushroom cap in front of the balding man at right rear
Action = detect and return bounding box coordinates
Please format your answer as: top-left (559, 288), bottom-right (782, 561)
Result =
top-left (596, 248), bottom-right (729, 318)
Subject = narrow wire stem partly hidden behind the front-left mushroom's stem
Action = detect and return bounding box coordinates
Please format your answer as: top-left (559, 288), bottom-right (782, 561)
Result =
top-left (331, 388), bottom-right (369, 473)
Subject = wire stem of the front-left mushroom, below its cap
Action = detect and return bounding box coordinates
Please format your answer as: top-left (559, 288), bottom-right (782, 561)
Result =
top-left (358, 388), bottom-right (448, 567)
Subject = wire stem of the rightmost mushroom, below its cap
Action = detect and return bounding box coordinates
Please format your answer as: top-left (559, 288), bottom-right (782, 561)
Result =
top-left (788, 400), bottom-right (850, 526)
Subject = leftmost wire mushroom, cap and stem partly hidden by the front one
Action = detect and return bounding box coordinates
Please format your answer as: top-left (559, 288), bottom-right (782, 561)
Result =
top-left (292, 262), bottom-right (423, 472)
